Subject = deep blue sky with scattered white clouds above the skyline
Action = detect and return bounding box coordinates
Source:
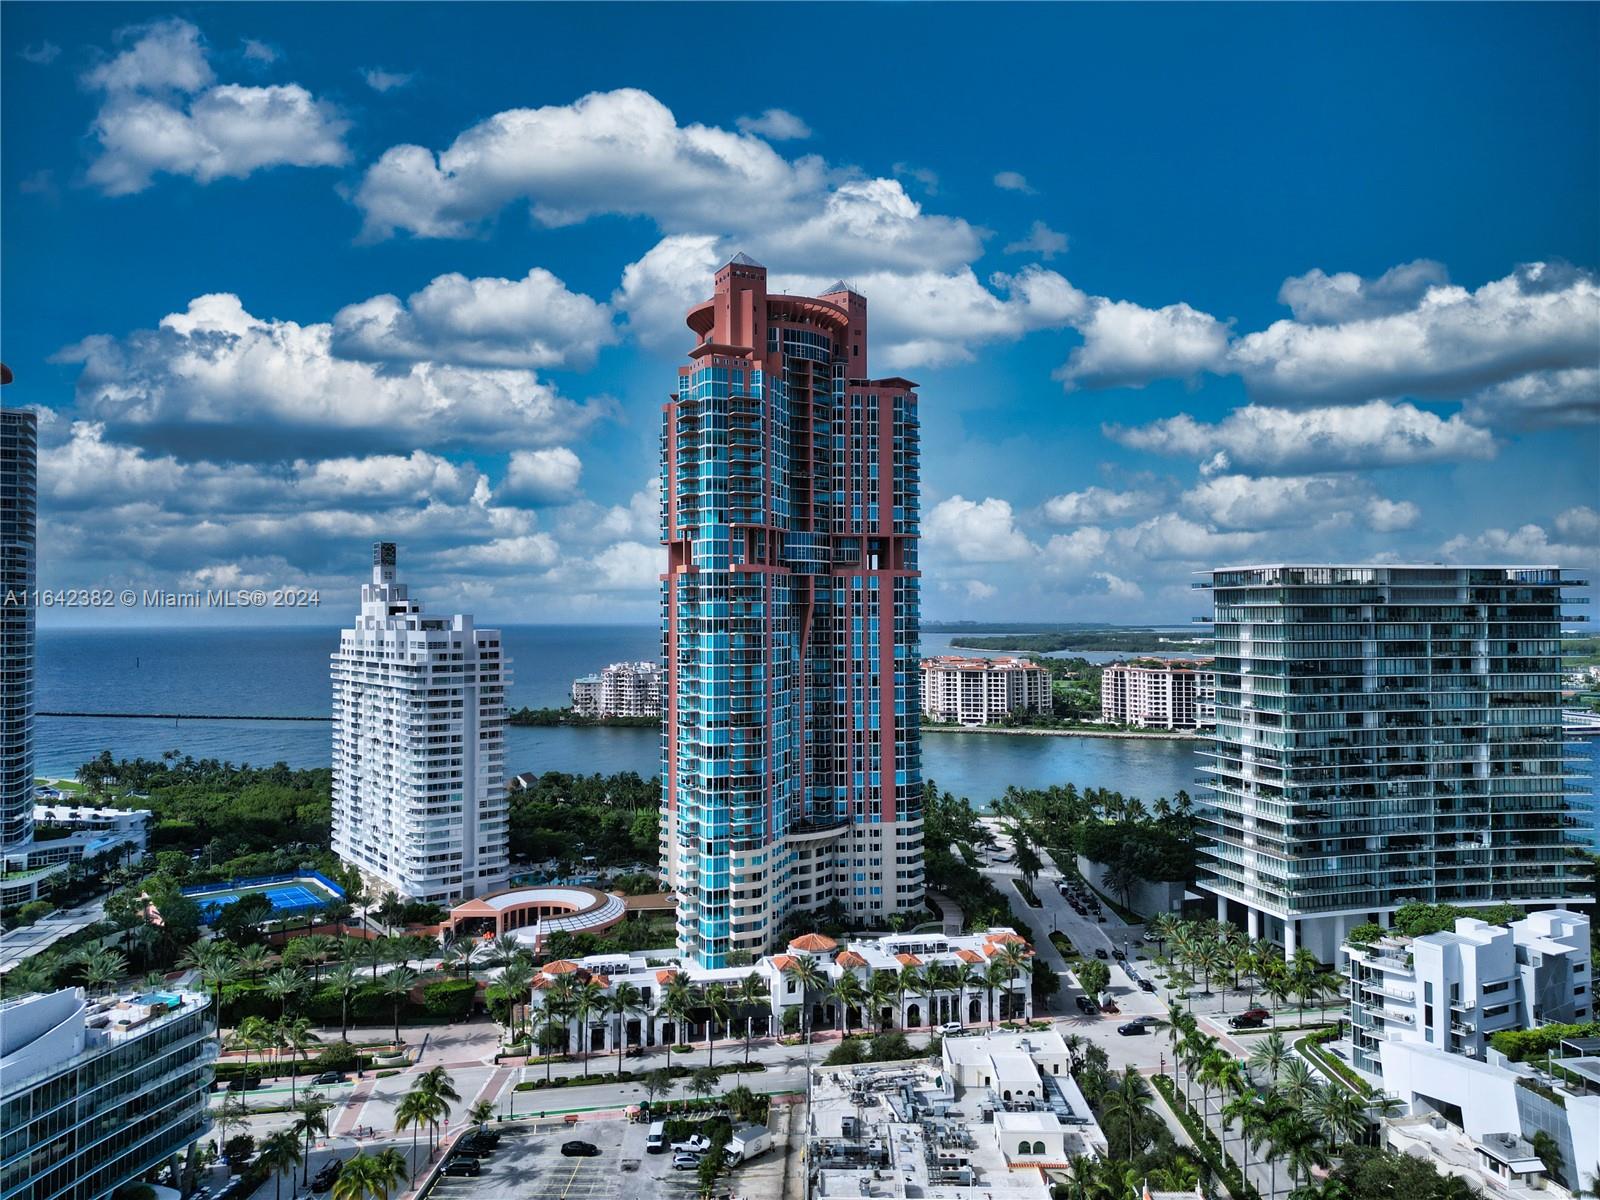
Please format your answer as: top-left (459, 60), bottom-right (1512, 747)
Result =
top-left (0, 5), bottom-right (1600, 622)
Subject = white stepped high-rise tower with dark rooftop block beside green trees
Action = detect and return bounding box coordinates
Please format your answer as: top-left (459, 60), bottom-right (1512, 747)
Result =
top-left (331, 542), bottom-right (510, 904)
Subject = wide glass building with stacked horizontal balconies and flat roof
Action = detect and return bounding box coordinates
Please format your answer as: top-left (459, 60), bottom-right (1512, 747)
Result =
top-left (1198, 565), bottom-right (1589, 962)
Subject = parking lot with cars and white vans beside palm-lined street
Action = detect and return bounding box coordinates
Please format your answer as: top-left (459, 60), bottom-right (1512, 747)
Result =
top-left (429, 1112), bottom-right (787, 1200)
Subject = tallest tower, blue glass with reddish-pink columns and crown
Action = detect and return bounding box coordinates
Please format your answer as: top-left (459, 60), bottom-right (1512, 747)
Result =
top-left (661, 254), bottom-right (923, 966)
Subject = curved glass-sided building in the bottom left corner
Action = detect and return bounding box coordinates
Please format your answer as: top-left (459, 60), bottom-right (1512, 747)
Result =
top-left (0, 987), bottom-right (218, 1200)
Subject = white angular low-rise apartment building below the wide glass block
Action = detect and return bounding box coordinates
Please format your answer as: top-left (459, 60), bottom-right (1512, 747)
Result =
top-left (1344, 909), bottom-right (1595, 1075)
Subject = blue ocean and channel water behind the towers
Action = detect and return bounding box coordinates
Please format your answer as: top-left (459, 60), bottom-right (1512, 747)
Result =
top-left (37, 626), bottom-right (1197, 803)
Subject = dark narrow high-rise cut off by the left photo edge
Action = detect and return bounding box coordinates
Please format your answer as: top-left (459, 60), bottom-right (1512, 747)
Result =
top-left (0, 408), bottom-right (38, 850)
